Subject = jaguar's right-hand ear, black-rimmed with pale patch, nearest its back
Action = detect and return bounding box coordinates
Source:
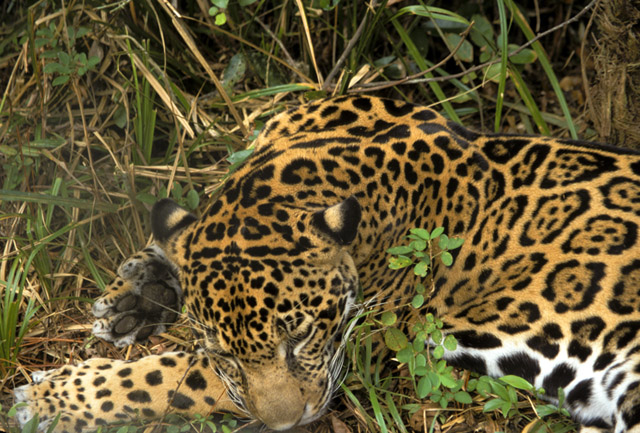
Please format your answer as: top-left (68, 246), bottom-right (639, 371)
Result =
top-left (311, 196), bottom-right (362, 245)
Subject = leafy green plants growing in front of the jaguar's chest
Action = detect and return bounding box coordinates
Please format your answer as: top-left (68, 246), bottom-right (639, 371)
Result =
top-left (343, 227), bottom-right (575, 433)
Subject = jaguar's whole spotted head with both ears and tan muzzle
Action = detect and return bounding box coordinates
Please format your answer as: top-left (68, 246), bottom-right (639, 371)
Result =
top-left (152, 197), bottom-right (361, 430)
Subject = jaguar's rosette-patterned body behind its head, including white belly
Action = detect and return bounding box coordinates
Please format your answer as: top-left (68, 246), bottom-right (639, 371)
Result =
top-left (247, 98), bottom-right (640, 431)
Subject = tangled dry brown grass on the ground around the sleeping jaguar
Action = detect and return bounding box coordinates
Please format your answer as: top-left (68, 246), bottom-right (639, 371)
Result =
top-left (0, 0), bottom-right (600, 432)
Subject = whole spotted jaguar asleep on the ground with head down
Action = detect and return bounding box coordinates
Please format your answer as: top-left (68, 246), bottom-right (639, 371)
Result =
top-left (15, 96), bottom-right (640, 433)
